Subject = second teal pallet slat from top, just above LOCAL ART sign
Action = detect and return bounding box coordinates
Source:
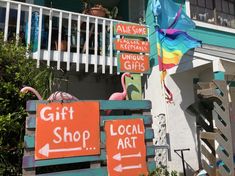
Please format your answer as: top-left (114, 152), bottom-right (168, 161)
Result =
top-left (26, 115), bottom-right (153, 130)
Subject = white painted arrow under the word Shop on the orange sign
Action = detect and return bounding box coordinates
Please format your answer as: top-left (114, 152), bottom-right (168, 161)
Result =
top-left (38, 144), bottom-right (82, 157)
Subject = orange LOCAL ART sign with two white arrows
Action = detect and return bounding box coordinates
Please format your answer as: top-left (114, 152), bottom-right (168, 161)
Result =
top-left (105, 119), bottom-right (148, 176)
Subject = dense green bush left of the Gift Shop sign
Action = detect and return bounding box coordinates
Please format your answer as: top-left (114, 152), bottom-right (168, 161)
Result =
top-left (0, 34), bottom-right (53, 175)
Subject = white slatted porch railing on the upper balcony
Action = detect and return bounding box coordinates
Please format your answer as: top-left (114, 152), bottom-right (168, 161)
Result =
top-left (0, 0), bottom-right (147, 74)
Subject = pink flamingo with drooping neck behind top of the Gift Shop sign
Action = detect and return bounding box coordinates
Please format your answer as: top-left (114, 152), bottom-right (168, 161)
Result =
top-left (20, 86), bottom-right (79, 101)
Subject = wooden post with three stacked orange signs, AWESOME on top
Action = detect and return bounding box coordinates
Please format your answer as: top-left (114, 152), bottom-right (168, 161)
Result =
top-left (114, 23), bottom-right (150, 100)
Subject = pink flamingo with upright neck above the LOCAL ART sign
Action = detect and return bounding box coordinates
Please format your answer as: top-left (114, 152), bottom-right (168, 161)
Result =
top-left (106, 73), bottom-right (131, 115)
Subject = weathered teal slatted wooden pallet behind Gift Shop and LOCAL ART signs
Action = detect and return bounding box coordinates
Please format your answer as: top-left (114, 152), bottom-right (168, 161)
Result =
top-left (22, 100), bottom-right (156, 176)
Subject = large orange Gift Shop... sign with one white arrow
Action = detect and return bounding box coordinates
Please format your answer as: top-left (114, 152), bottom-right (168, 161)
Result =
top-left (35, 102), bottom-right (100, 160)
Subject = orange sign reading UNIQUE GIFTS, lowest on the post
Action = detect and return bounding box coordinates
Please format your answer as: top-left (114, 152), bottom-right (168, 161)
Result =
top-left (118, 53), bottom-right (150, 73)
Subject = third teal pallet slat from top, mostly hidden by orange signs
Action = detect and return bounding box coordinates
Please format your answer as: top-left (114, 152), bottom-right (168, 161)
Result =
top-left (24, 128), bottom-right (154, 149)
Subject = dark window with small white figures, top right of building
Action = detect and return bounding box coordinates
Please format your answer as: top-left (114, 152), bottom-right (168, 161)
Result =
top-left (189, 0), bottom-right (235, 28)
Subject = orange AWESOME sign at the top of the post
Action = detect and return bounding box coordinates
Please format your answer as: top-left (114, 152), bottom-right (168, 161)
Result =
top-left (114, 23), bottom-right (148, 37)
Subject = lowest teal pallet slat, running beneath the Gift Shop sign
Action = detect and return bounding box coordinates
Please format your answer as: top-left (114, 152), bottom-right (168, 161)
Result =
top-left (38, 161), bottom-right (156, 176)
